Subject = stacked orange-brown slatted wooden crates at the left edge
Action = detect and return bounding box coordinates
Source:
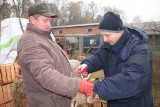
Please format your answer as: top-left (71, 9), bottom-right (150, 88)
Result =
top-left (0, 63), bottom-right (20, 107)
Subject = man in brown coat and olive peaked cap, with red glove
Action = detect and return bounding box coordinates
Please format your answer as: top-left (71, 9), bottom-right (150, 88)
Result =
top-left (18, 3), bottom-right (93, 107)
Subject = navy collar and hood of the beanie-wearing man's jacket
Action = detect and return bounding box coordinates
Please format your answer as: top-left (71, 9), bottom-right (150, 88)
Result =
top-left (103, 27), bottom-right (148, 61)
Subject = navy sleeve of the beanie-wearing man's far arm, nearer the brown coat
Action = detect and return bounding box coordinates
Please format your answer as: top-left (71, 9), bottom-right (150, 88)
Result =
top-left (81, 46), bottom-right (107, 73)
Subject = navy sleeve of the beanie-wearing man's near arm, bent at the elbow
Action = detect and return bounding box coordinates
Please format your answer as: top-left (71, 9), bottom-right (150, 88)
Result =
top-left (94, 45), bottom-right (152, 100)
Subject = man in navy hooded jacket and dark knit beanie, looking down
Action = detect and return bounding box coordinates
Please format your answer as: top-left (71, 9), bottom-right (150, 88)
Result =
top-left (77, 12), bottom-right (153, 107)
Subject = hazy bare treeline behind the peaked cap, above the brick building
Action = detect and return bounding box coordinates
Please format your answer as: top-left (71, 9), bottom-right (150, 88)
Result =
top-left (0, 0), bottom-right (127, 26)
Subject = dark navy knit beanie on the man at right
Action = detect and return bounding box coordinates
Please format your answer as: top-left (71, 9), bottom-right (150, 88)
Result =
top-left (98, 12), bottom-right (123, 32)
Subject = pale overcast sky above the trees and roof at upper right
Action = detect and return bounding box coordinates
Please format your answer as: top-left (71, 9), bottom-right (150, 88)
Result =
top-left (69, 0), bottom-right (160, 22)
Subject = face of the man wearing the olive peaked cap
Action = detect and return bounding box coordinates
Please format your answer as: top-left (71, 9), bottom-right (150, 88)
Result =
top-left (30, 15), bottom-right (51, 31)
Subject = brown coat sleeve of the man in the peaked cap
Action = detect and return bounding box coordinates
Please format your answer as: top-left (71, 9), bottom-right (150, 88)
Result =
top-left (19, 38), bottom-right (80, 97)
